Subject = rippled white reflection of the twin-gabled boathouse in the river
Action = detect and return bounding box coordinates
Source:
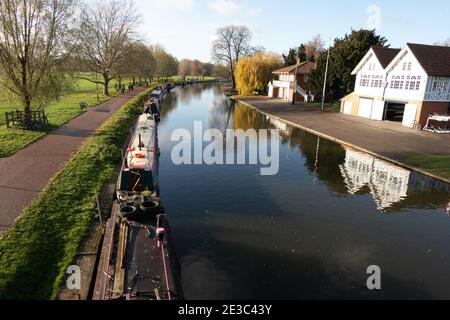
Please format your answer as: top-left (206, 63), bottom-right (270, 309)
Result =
top-left (340, 149), bottom-right (450, 211)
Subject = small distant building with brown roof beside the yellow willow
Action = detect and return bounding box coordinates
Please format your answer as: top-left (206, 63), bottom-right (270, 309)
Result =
top-left (269, 61), bottom-right (316, 102)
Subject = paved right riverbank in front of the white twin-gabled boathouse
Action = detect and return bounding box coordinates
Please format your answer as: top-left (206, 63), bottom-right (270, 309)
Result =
top-left (232, 96), bottom-right (450, 183)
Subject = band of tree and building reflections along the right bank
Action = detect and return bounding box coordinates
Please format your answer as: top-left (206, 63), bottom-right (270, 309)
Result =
top-left (232, 103), bottom-right (450, 212)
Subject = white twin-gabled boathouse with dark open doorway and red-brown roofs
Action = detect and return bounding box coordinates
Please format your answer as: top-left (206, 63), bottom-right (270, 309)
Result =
top-left (341, 43), bottom-right (450, 127)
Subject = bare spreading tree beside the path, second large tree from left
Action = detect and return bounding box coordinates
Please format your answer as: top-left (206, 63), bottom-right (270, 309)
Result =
top-left (77, 0), bottom-right (139, 96)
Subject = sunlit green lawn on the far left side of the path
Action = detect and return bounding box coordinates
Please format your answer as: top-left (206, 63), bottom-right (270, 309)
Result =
top-left (0, 75), bottom-right (127, 158)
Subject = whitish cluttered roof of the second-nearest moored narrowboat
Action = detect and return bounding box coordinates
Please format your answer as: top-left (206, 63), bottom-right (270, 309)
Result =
top-left (127, 115), bottom-right (157, 171)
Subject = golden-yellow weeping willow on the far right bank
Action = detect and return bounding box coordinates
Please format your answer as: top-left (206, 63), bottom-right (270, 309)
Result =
top-left (236, 53), bottom-right (281, 95)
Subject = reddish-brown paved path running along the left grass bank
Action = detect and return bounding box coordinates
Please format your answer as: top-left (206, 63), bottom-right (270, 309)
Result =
top-left (0, 88), bottom-right (144, 233)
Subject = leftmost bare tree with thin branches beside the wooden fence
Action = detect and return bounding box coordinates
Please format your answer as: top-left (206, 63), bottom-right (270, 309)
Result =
top-left (0, 0), bottom-right (75, 126)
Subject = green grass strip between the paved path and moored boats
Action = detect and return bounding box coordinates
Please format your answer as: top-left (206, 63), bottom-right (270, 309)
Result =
top-left (0, 89), bottom-right (151, 300)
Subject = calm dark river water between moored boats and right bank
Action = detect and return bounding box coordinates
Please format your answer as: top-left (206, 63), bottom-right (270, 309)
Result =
top-left (160, 85), bottom-right (450, 299)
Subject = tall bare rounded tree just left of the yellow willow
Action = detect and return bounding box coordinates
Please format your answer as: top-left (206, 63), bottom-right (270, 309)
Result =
top-left (212, 25), bottom-right (252, 88)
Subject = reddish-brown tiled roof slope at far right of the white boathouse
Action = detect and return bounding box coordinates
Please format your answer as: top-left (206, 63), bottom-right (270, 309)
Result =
top-left (407, 43), bottom-right (450, 77)
